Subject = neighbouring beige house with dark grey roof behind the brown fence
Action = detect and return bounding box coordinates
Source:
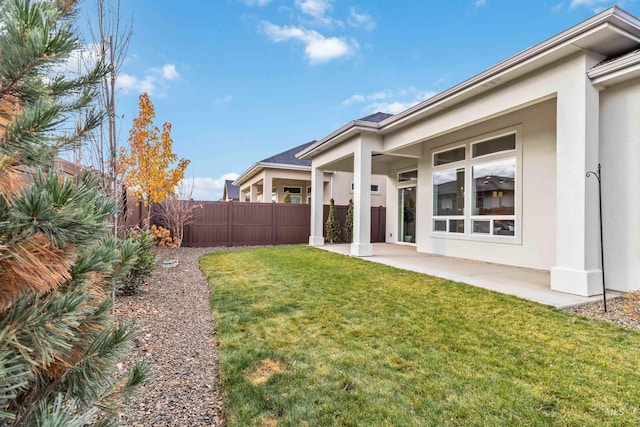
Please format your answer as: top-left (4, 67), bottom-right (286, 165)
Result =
top-left (233, 113), bottom-right (391, 206)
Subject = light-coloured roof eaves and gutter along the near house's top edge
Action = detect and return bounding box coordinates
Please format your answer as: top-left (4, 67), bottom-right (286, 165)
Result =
top-left (298, 6), bottom-right (640, 159)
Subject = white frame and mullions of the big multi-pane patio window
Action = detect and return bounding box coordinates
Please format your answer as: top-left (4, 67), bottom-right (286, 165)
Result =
top-left (429, 125), bottom-right (523, 244)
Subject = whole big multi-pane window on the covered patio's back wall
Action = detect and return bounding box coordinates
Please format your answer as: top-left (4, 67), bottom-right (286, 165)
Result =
top-left (431, 131), bottom-right (519, 238)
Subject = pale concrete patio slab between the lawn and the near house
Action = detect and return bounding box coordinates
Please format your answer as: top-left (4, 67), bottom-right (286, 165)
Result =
top-left (318, 243), bottom-right (622, 308)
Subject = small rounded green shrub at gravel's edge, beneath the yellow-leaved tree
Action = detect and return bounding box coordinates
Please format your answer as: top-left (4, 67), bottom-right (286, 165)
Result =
top-left (115, 230), bottom-right (156, 295)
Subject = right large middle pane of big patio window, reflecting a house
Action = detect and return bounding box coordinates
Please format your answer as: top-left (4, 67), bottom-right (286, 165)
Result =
top-left (472, 158), bottom-right (516, 215)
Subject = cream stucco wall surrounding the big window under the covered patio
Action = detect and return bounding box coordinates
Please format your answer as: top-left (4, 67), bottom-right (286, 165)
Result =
top-left (387, 100), bottom-right (556, 270)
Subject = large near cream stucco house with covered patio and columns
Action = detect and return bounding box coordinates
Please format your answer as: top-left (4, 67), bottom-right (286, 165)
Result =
top-left (298, 7), bottom-right (640, 295)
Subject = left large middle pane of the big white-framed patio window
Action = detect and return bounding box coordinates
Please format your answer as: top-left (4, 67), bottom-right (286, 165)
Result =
top-left (433, 168), bottom-right (464, 216)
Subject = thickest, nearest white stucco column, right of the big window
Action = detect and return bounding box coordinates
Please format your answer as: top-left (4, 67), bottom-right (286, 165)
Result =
top-left (551, 51), bottom-right (602, 296)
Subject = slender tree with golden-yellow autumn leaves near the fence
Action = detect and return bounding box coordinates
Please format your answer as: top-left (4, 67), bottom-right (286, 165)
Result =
top-left (118, 93), bottom-right (189, 227)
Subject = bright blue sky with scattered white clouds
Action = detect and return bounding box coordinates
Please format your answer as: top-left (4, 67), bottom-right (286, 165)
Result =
top-left (81, 0), bottom-right (640, 200)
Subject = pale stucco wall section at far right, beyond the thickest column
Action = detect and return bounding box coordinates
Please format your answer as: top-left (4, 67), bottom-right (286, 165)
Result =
top-left (600, 79), bottom-right (640, 292)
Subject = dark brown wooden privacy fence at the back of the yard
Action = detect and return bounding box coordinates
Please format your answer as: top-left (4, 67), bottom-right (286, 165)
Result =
top-left (170, 202), bottom-right (386, 247)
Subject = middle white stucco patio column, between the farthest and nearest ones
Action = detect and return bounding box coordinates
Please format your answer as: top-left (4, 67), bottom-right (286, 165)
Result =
top-left (351, 135), bottom-right (373, 256)
